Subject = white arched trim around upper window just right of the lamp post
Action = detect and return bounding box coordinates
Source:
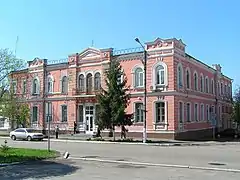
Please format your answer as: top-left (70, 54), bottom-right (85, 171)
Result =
top-left (152, 61), bottom-right (168, 90)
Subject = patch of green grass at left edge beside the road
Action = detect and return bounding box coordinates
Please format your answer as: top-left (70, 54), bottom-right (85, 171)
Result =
top-left (0, 148), bottom-right (57, 164)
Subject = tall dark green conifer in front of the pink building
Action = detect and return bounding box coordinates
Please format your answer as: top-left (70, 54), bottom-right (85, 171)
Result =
top-left (97, 60), bottom-right (131, 140)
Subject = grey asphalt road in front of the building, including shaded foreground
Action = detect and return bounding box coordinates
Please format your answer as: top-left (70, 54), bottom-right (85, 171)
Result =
top-left (0, 139), bottom-right (240, 180)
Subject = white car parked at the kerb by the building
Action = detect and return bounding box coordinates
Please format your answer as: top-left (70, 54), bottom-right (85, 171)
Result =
top-left (10, 128), bottom-right (44, 141)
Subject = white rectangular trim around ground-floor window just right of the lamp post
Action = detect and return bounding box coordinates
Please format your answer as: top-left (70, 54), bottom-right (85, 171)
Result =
top-left (152, 100), bottom-right (168, 131)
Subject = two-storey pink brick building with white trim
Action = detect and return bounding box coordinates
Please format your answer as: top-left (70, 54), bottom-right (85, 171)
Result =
top-left (12, 38), bottom-right (232, 139)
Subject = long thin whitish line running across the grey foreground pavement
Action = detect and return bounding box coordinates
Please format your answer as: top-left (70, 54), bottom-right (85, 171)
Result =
top-left (69, 156), bottom-right (240, 173)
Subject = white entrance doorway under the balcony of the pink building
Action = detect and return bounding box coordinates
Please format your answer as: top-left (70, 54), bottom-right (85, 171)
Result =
top-left (85, 105), bottom-right (94, 134)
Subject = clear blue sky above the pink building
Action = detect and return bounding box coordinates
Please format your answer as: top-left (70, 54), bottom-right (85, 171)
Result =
top-left (0, 0), bottom-right (240, 87)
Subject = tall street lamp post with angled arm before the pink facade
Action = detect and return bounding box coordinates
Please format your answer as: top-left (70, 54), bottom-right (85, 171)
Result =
top-left (135, 38), bottom-right (147, 143)
